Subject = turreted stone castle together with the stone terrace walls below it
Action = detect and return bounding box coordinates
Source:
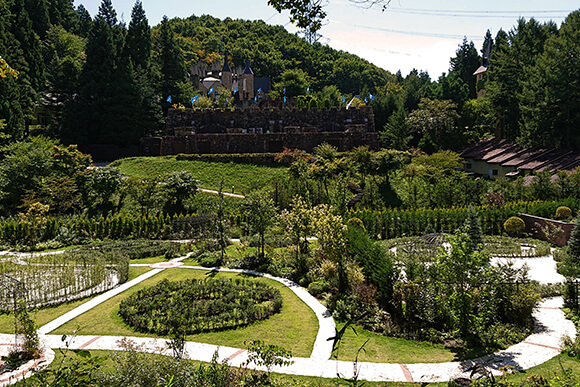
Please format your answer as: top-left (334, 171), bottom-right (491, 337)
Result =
top-left (140, 54), bottom-right (379, 156)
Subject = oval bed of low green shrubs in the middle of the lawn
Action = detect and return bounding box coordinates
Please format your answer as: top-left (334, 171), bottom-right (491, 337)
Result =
top-left (119, 279), bottom-right (282, 335)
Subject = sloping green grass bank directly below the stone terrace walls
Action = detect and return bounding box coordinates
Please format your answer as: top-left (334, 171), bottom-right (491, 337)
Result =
top-left (112, 156), bottom-right (287, 194)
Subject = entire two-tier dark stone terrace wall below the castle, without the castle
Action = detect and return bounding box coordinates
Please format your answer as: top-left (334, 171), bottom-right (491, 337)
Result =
top-left (140, 106), bottom-right (379, 156)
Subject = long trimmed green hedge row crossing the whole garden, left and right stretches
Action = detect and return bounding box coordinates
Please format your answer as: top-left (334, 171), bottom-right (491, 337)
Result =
top-left (0, 198), bottom-right (580, 245)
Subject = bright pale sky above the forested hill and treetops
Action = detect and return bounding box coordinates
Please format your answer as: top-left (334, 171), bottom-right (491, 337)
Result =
top-left (74, 0), bottom-right (579, 79)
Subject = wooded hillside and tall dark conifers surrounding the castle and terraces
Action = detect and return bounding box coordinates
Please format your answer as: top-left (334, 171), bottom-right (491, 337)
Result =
top-left (0, 0), bottom-right (580, 152)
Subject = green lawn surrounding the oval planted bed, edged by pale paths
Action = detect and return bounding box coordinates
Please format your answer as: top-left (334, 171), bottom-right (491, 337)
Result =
top-left (51, 268), bottom-right (318, 357)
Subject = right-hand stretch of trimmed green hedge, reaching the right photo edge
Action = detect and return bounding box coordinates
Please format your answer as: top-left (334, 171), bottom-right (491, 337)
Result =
top-left (345, 198), bottom-right (580, 239)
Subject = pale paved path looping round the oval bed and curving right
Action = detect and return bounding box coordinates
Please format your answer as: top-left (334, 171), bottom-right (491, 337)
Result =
top-left (0, 250), bottom-right (576, 385)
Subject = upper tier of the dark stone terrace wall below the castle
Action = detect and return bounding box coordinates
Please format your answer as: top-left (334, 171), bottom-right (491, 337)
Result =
top-left (165, 106), bottom-right (375, 136)
